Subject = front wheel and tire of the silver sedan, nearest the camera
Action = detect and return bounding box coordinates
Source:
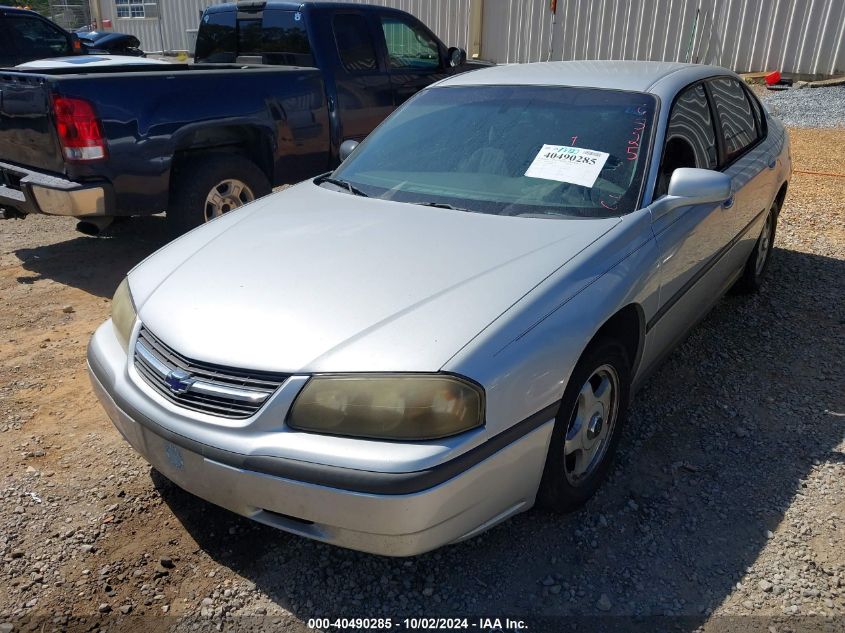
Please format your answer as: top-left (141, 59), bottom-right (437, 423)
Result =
top-left (537, 338), bottom-right (631, 513)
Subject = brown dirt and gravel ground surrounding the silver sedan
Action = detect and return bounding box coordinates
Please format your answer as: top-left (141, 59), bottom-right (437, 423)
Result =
top-left (0, 124), bottom-right (845, 633)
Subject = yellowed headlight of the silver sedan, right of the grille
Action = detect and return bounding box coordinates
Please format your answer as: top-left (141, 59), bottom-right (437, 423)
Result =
top-left (287, 374), bottom-right (484, 440)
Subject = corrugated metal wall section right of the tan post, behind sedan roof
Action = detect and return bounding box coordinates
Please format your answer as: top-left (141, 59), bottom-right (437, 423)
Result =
top-left (482, 0), bottom-right (845, 74)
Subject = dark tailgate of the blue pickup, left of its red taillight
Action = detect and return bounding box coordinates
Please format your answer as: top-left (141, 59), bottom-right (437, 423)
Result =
top-left (0, 71), bottom-right (64, 173)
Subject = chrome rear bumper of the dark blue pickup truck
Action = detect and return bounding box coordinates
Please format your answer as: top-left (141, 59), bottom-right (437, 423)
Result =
top-left (0, 162), bottom-right (112, 218)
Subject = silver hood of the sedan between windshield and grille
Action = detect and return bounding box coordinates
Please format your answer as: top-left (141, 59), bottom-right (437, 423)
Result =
top-left (134, 182), bottom-right (619, 372)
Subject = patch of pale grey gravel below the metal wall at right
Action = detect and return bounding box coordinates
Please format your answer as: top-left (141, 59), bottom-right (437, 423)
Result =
top-left (757, 86), bottom-right (845, 128)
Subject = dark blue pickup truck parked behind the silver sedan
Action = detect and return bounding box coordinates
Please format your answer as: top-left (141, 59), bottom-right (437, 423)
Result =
top-left (0, 0), bottom-right (479, 234)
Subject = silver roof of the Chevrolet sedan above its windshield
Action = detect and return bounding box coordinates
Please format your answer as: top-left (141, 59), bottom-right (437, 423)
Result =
top-left (437, 60), bottom-right (734, 98)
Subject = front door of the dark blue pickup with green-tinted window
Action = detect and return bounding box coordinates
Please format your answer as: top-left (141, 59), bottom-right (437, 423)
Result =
top-left (379, 12), bottom-right (448, 106)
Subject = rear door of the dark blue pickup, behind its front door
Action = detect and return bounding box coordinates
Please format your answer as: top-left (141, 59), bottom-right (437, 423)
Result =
top-left (331, 11), bottom-right (393, 141)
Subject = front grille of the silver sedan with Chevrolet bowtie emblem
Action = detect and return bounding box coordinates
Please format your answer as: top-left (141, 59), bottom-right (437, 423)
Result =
top-left (135, 326), bottom-right (288, 419)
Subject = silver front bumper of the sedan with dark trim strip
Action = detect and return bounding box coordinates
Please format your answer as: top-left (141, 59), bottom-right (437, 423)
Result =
top-left (88, 322), bottom-right (553, 556)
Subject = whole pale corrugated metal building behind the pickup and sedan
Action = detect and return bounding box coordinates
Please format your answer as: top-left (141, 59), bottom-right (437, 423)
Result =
top-left (90, 0), bottom-right (845, 75)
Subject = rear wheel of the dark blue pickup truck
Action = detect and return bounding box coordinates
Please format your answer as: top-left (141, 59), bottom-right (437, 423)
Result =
top-left (172, 154), bottom-right (270, 236)
